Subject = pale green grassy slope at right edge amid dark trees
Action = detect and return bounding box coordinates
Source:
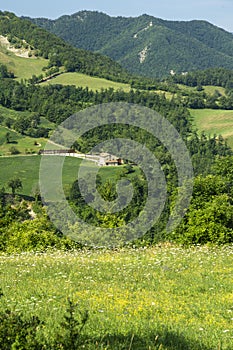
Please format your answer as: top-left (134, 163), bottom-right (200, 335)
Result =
top-left (190, 109), bottom-right (233, 147)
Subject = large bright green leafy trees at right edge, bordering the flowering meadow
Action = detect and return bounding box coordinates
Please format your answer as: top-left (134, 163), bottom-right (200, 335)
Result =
top-left (172, 175), bottom-right (233, 245)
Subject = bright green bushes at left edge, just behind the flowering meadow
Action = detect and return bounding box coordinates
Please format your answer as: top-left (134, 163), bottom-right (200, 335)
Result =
top-left (0, 201), bottom-right (80, 253)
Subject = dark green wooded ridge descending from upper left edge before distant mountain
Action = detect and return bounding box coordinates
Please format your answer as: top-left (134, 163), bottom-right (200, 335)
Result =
top-left (0, 11), bottom-right (128, 81)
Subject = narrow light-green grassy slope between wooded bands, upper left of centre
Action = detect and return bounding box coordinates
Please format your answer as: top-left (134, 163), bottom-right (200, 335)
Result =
top-left (42, 73), bottom-right (130, 91)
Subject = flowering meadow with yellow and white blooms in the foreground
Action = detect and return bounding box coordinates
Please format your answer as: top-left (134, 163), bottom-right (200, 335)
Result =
top-left (0, 245), bottom-right (233, 350)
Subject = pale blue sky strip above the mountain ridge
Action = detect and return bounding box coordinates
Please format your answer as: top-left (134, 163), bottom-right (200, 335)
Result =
top-left (0, 0), bottom-right (233, 32)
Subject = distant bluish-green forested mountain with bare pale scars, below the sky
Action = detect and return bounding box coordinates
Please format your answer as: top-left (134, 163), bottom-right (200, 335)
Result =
top-left (26, 11), bottom-right (233, 77)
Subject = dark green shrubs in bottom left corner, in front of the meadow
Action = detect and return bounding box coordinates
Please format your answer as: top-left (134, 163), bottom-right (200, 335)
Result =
top-left (0, 292), bottom-right (88, 350)
